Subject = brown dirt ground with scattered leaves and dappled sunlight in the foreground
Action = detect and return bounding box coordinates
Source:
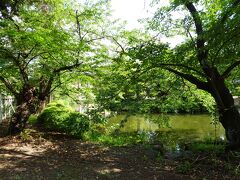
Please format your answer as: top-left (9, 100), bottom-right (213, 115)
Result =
top-left (0, 127), bottom-right (240, 180)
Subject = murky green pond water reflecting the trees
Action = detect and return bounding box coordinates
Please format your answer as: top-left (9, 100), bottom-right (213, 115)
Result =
top-left (109, 114), bottom-right (225, 150)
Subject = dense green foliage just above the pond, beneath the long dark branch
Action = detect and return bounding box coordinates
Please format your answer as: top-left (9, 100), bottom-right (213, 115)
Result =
top-left (96, 64), bottom-right (212, 113)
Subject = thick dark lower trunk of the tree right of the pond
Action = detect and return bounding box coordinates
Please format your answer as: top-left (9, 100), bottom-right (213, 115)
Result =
top-left (211, 74), bottom-right (240, 150)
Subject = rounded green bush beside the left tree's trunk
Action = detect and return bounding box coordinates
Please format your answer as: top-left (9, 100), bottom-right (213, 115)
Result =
top-left (38, 102), bottom-right (89, 138)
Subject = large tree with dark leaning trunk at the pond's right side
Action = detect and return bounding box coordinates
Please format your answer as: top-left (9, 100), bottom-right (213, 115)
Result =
top-left (126, 0), bottom-right (240, 148)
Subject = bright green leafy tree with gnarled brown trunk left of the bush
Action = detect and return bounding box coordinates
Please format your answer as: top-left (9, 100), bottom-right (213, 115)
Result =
top-left (0, 0), bottom-right (108, 134)
